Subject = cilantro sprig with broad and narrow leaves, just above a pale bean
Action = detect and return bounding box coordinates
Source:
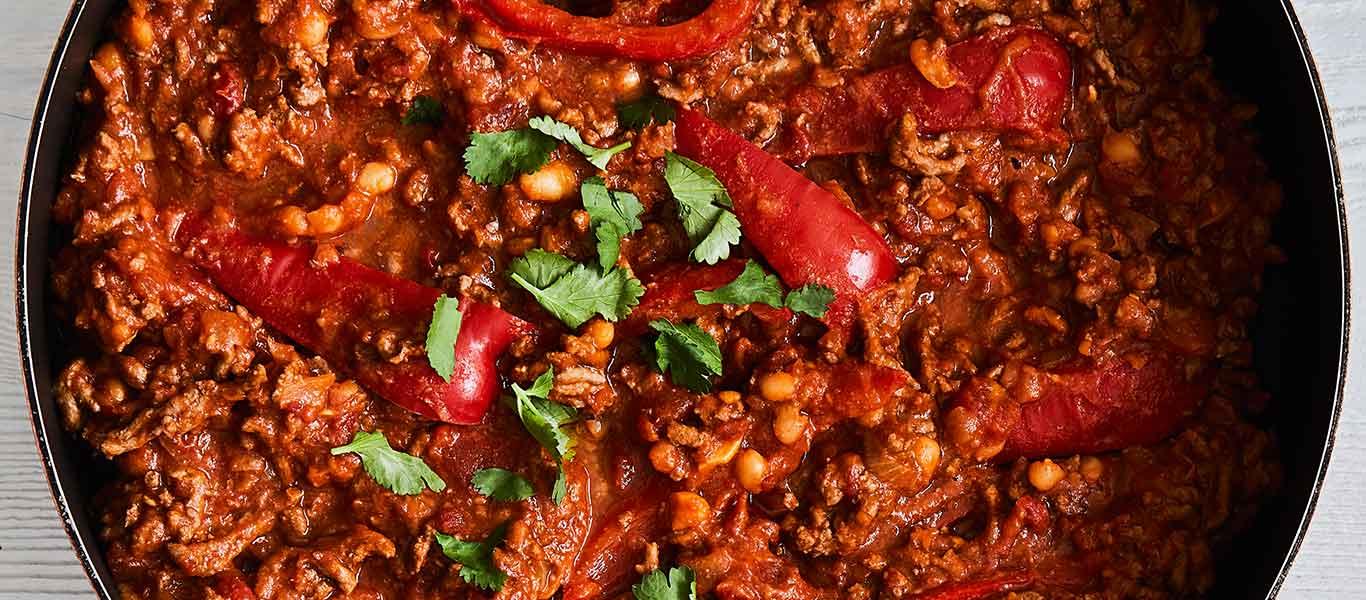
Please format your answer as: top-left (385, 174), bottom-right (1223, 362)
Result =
top-left (464, 116), bottom-right (631, 186)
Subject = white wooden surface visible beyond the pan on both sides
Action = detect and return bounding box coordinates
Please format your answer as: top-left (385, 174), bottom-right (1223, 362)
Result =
top-left (0, 0), bottom-right (1366, 600)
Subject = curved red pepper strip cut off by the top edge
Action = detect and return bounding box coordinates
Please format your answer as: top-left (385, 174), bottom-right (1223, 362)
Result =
top-left (455, 0), bottom-right (758, 63)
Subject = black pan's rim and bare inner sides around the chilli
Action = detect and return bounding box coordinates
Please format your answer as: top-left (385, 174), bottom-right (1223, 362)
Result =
top-left (15, 0), bottom-right (1350, 599)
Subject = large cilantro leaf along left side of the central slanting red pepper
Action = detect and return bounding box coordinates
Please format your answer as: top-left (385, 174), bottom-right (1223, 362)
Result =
top-left (664, 152), bottom-right (740, 265)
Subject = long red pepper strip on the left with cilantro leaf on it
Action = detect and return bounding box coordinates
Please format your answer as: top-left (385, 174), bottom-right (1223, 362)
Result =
top-left (178, 220), bottom-right (534, 425)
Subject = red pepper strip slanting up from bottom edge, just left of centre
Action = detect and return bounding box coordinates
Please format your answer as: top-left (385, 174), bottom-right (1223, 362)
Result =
top-left (561, 480), bottom-right (668, 600)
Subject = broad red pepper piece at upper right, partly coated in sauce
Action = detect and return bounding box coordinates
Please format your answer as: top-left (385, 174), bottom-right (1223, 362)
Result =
top-left (779, 27), bottom-right (1072, 161)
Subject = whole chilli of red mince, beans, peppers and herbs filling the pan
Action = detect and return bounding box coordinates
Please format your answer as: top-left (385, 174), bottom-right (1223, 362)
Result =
top-left (52, 0), bottom-right (1283, 600)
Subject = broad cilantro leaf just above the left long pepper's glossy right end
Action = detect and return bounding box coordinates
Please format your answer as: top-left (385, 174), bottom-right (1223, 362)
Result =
top-left (508, 249), bottom-right (645, 327)
